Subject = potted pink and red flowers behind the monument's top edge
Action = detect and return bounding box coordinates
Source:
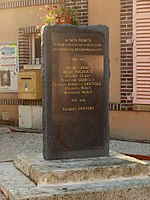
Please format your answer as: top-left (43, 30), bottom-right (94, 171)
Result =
top-left (42, 5), bottom-right (80, 26)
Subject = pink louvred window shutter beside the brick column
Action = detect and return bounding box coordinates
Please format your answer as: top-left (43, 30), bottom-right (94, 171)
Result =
top-left (133, 0), bottom-right (150, 104)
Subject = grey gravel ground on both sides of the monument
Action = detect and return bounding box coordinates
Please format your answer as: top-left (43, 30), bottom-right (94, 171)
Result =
top-left (0, 127), bottom-right (150, 162)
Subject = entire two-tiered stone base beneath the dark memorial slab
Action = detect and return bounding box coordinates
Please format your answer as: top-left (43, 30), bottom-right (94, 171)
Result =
top-left (0, 154), bottom-right (150, 200)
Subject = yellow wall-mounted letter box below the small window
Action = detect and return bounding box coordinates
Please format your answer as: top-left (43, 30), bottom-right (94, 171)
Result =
top-left (18, 71), bottom-right (42, 100)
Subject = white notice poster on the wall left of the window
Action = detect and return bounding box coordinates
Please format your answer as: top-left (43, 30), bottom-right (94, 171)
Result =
top-left (0, 42), bottom-right (18, 92)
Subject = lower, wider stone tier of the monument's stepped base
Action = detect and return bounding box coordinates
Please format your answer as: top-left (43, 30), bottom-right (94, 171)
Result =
top-left (0, 163), bottom-right (150, 200)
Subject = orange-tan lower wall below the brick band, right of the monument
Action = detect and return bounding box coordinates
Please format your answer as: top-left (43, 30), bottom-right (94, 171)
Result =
top-left (110, 111), bottom-right (150, 140)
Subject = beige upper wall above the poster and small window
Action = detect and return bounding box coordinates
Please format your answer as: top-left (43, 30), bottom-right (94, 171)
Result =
top-left (0, 6), bottom-right (47, 42)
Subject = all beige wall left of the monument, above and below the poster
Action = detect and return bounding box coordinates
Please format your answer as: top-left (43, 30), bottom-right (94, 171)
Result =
top-left (0, 4), bottom-right (47, 125)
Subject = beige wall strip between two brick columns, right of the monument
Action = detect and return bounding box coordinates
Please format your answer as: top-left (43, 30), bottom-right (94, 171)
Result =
top-left (88, 0), bottom-right (120, 103)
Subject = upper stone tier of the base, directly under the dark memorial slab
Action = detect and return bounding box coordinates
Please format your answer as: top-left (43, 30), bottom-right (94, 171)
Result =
top-left (15, 153), bottom-right (149, 186)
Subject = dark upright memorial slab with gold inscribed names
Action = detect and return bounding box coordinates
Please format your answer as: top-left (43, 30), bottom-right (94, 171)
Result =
top-left (42, 25), bottom-right (109, 160)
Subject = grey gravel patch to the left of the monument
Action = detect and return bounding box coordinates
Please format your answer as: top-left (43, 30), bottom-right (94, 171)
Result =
top-left (0, 128), bottom-right (43, 162)
